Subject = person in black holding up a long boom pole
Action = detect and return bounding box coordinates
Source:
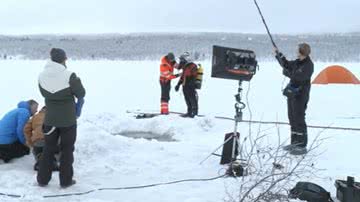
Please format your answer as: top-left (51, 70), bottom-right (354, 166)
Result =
top-left (275, 43), bottom-right (314, 155)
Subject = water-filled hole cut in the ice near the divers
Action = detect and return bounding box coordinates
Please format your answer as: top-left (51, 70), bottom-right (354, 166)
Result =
top-left (113, 131), bottom-right (177, 142)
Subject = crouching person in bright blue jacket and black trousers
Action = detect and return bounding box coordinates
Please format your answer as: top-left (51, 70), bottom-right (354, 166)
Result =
top-left (0, 100), bottom-right (39, 163)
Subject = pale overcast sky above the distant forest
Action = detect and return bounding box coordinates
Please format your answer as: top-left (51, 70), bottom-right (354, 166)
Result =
top-left (0, 0), bottom-right (360, 35)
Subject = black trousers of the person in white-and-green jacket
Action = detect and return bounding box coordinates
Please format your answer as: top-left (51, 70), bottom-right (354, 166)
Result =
top-left (37, 125), bottom-right (77, 186)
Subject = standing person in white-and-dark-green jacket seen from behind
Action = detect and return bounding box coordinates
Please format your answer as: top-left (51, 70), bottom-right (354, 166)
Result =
top-left (37, 48), bottom-right (85, 188)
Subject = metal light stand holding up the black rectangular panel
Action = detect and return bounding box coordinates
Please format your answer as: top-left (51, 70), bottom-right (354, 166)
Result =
top-left (200, 80), bottom-right (246, 164)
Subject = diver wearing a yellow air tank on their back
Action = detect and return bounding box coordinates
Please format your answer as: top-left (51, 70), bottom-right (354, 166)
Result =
top-left (175, 52), bottom-right (198, 118)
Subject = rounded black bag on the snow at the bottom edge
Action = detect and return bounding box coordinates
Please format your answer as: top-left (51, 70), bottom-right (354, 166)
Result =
top-left (289, 182), bottom-right (333, 202)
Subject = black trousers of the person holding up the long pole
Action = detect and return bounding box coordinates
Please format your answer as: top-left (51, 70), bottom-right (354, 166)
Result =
top-left (287, 94), bottom-right (309, 147)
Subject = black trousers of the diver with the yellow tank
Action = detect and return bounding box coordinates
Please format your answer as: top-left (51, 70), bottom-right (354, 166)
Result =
top-left (183, 85), bottom-right (199, 116)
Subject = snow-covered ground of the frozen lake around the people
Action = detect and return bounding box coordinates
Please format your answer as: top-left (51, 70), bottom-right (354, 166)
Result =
top-left (0, 60), bottom-right (360, 202)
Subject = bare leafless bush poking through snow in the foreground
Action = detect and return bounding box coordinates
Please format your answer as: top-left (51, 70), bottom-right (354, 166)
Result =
top-left (227, 126), bottom-right (324, 202)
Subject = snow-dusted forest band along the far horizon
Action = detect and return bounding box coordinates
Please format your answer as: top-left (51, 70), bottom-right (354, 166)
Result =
top-left (0, 33), bottom-right (360, 62)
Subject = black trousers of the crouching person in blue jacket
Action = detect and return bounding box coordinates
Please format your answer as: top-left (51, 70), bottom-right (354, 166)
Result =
top-left (0, 141), bottom-right (30, 163)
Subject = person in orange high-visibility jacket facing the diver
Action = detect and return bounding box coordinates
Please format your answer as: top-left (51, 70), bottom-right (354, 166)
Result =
top-left (160, 53), bottom-right (179, 114)
